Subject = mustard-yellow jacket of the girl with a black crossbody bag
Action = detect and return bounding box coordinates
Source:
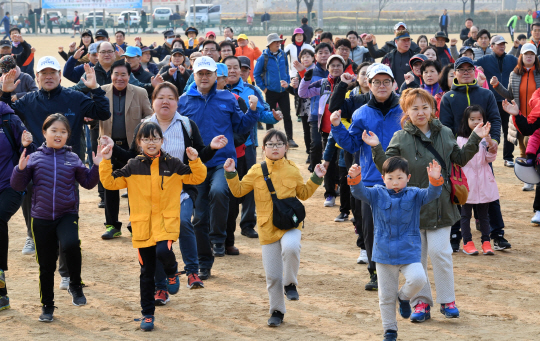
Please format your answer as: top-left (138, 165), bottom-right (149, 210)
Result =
top-left (225, 158), bottom-right (323, 245)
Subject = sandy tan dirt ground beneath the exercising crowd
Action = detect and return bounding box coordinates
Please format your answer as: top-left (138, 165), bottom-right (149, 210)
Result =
top-left (0, 35), bottom-right (540, 341)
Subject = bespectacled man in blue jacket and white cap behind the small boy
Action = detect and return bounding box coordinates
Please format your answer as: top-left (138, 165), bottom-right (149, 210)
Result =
top-left (330, 64), bottom-right (403, 290)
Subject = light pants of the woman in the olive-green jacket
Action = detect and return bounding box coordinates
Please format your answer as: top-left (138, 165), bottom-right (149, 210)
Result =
top-left (411, 226), bottom-right (456, 306)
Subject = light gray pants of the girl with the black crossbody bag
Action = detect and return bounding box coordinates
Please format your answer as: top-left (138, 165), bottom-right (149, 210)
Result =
top-left (262, 229), bottom-right (302, 314)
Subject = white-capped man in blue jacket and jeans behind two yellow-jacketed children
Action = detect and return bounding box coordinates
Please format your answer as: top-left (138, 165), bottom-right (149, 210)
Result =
top-left (178, 56), bottom-right (259, 280)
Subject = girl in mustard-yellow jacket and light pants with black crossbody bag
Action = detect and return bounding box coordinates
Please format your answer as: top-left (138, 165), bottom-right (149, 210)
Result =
top-left (224, 129), bottom-right (326, 327)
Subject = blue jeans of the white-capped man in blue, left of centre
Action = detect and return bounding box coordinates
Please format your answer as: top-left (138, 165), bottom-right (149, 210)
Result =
top-left (193, 165), bottom-right (229, 269)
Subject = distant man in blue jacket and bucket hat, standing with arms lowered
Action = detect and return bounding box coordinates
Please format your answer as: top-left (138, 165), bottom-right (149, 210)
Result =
top-left (253, 33), bottom-right (298, 148)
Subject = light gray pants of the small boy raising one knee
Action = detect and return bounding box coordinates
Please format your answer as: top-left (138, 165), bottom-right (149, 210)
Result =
top-left (376, 263), bottom-right (429, 331)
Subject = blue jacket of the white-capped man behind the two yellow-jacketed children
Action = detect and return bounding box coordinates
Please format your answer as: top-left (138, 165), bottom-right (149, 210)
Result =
top-left (177, 83), bottom-right (259, 168)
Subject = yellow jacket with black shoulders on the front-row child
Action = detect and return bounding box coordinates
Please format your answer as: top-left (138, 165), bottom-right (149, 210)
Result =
top-left (99, 152), bottom-right (206, 248)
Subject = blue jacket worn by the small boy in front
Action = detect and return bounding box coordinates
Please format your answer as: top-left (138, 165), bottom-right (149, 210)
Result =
top-left (351, 182), bottom-right (442, 265)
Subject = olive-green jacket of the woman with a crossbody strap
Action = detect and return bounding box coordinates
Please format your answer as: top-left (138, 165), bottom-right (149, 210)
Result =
top-left (371, 119), bottom-right (482, 230)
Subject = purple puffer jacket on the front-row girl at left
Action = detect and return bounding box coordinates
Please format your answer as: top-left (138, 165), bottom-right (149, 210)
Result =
top-left (11, 143), bottom-right (99, 220)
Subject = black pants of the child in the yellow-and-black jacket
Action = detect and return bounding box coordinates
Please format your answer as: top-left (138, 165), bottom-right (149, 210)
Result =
top-left (138, 240), bottom-right (178, 315)
